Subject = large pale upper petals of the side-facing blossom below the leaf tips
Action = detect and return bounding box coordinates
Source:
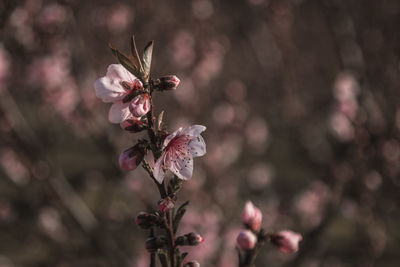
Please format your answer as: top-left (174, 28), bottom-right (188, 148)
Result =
top-left (93, 64), bottom-right (136, 103)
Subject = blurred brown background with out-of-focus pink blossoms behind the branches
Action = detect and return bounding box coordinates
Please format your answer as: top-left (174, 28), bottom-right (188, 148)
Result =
top-left (0, 0), bottom-right (400, 267)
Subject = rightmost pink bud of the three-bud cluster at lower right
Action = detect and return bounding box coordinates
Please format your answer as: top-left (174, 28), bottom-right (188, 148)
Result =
top-left (269, 230), bottom-right (303, 253)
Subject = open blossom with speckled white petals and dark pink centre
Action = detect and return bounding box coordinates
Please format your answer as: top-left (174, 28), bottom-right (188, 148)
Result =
top-left (154, 125), bottom-right (206, 183)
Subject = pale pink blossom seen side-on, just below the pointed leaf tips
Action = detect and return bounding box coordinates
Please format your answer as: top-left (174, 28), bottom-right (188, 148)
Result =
top-left (94, 64), bottom-right (142, 123)
